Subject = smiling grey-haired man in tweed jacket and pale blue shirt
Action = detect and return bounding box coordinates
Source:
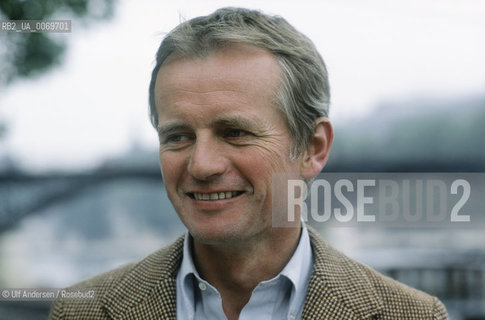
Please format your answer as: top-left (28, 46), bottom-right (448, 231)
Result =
top-left (47, 8), bottom-right (447, 320)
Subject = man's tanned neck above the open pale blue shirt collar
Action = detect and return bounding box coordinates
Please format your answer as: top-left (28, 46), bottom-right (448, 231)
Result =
top-left (193, 227), bottom-right (301, 319)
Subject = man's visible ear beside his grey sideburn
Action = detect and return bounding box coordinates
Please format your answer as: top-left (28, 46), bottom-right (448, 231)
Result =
top-left (300, 117), bottom-right (333, 179)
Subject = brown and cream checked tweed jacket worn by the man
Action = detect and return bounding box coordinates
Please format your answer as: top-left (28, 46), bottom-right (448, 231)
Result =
top-left (49, 228), bottom-right (448, 320)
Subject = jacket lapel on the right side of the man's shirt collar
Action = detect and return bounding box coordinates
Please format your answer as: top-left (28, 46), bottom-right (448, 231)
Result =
top-left (302, 227), bottom-right (382, 319)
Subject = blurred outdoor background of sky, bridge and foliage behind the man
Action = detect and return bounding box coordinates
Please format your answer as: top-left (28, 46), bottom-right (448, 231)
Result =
top-left (0, 0), bottom-right (485, 320)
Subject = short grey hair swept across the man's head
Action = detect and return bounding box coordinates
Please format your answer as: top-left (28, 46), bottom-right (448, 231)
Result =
top-left (149, 8), bottom-right (330, 159)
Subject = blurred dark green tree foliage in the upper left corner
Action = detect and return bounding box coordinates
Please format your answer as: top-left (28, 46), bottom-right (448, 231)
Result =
top-left (0, 0), bottom-right (116, 86)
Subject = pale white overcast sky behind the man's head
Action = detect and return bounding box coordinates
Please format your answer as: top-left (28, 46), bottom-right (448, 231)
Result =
top-left (0, 0), bottom-right (485, 171)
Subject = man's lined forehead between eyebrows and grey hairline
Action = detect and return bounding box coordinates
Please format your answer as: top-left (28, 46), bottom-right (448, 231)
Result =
top-left (155, 44), bottom-right (281, 113)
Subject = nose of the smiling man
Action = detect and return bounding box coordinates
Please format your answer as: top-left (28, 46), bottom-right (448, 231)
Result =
top-left (188, 136), bottom-right (227, 181)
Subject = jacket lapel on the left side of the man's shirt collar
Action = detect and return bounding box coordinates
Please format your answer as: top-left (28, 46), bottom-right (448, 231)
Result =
top-left (101, 237), bottom-right (183, 320)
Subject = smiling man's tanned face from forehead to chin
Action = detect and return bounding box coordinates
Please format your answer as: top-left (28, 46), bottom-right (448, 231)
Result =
top-left (155, 45), bottom-right (299, 244)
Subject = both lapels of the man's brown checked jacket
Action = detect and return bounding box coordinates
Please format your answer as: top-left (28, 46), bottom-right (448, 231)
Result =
top-left (101, 227), bottom-right (382, 320)
